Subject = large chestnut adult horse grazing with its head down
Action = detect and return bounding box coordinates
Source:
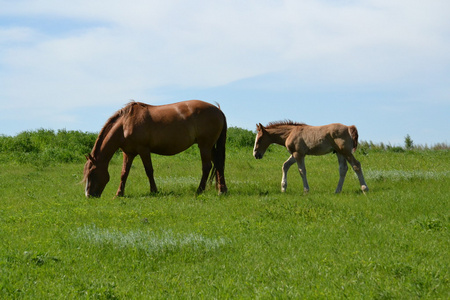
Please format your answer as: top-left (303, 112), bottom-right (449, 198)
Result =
top-left (84, 100), bottom-right (227, 197)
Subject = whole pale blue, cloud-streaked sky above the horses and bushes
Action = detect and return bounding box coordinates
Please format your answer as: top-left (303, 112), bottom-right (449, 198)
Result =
top-left (0, 0), bottom-right (450, 145)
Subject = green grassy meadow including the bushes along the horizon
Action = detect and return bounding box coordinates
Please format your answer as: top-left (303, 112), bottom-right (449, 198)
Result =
top-left (0, 128), bottom-right (450, 299)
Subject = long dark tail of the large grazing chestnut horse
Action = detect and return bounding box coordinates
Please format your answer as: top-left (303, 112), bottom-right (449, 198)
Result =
top-left (209, 115), bottom-right (227, 193)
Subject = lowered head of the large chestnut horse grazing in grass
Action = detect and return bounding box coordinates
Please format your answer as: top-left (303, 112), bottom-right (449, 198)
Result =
top-left (84, 154), bottom-right (109, 197)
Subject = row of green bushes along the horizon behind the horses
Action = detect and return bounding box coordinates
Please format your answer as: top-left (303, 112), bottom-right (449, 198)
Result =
top-left (0, 127), bottom-right (449, 166)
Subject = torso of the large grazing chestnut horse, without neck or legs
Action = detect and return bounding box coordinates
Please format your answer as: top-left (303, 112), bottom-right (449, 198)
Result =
top-left (124, 100), bottom-right (226, 155)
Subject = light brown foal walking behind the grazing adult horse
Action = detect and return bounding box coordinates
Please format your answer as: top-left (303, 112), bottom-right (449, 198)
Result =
top-left (253, 121), bottom-right (369, 193)
